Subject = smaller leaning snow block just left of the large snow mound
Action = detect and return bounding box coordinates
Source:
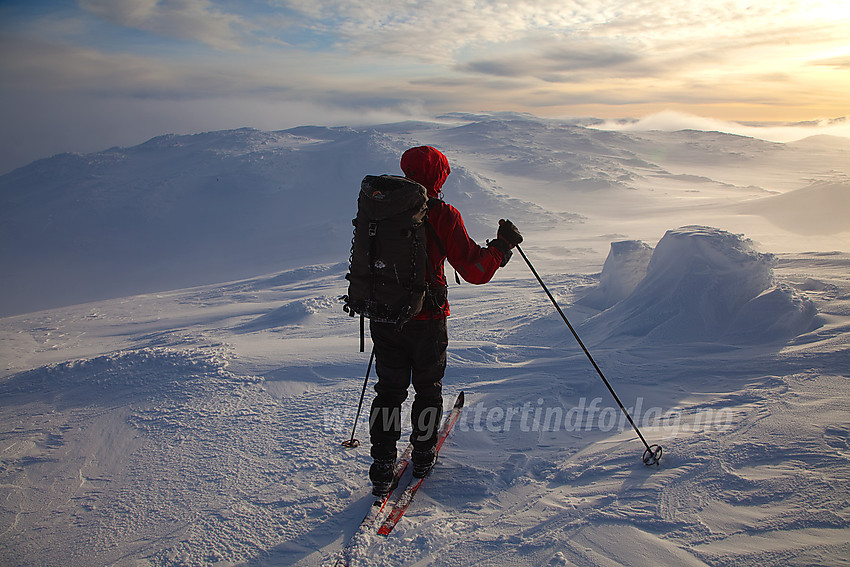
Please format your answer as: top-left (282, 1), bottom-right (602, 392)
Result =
top-left (578, 240), bottom-right (652, 309)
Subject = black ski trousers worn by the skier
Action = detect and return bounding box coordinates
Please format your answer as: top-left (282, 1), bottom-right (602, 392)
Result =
top-left (369, 319), bottom-right (449, 461)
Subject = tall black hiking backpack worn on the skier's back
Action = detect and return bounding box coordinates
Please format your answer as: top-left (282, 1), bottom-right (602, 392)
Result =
top-left (343, 175), bottom-right (429, 351)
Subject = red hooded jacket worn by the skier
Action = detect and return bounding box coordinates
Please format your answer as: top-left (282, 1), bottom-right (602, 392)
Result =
top-left (401, 146), bottom-right (503, 319)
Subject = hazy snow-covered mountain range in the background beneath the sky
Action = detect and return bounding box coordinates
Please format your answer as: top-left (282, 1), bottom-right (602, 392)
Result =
top-left (0, 115), bottom-right (850, 315)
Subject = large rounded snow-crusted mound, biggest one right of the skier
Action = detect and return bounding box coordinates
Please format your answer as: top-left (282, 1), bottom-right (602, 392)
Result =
top-left (584, 226), bottom-right (816, 343)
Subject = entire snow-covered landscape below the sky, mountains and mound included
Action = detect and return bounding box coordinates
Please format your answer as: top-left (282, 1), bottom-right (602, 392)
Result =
top-left (0, 115), bottom-right (850, 567)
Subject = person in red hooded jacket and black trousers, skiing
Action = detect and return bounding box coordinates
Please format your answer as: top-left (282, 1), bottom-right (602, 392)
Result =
top-left (369, 146), bottom-right (522, 496)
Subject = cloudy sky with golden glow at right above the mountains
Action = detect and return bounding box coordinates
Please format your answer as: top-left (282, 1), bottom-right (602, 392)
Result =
top-left (0, 0), bottom-right (850, 173)
